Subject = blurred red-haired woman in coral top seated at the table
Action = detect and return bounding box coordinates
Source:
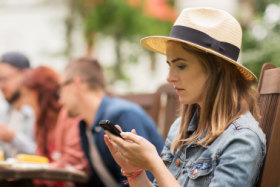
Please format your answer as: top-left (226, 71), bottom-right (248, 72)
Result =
top-left (21, 66), bottom-right (87, 187)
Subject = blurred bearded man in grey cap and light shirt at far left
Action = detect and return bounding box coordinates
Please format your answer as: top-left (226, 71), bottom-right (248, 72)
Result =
top-left (0, 52), bottom-right (36, 158)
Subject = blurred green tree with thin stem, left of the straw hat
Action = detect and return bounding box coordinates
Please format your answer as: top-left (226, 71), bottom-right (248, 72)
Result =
top-left (79, 0), bottom-right (172, 81)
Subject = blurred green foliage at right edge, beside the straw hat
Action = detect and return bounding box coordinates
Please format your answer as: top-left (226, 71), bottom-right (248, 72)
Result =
top-left (242, 0), bottom-right (280, 77)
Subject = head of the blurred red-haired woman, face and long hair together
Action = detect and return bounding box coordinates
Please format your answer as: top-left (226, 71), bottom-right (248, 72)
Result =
top-left (21, 66), bottom-right (61, 159)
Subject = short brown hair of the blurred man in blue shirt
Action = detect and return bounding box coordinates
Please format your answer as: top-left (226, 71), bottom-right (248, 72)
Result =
top-left (65, 57), bottom-right (106, 90)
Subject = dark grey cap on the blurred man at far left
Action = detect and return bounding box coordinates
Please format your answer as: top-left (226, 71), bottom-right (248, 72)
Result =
top-left (0, 52), bottom-right (30, 70)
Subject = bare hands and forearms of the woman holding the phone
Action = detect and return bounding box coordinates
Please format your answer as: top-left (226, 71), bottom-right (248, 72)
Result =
top-left (104, 127), bottom-right (180, 187)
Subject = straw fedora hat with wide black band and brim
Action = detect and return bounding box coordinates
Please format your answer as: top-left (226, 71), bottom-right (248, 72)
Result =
top-left (140, 8), bottom-right (257, 81)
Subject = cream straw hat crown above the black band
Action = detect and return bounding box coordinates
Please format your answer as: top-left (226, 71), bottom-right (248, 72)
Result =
top-left (174, 8), bottom-right (242, 49)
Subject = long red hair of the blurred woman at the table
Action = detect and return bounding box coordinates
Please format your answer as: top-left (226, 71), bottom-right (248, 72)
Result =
top-left (23, 66), bottom-right (61, 156)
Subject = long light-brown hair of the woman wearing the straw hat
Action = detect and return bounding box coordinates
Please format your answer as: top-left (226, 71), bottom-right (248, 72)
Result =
top-left (171, 43), bottom-right (260, 152)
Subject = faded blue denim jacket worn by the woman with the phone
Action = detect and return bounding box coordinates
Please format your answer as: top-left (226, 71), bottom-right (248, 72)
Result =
top-left (154, 112), bottom-right (266, 187)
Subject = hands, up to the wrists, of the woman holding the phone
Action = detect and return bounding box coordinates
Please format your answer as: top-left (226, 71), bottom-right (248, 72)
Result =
top-left (105, 127), bottom-right (161, 171)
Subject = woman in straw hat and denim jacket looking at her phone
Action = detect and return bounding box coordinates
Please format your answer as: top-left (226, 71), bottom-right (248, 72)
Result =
top-left (104, 8), bottom-right (265, 187)
